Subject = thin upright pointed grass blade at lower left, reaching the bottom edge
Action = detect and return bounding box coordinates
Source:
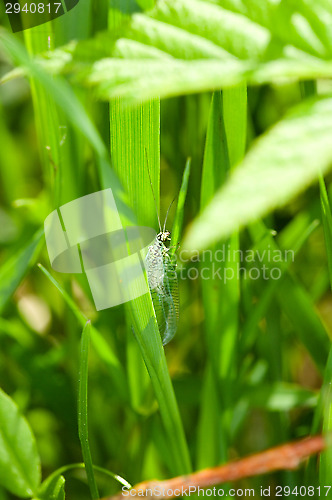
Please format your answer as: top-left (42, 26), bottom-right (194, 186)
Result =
top-left (78, 321), bottom-right (99, 500)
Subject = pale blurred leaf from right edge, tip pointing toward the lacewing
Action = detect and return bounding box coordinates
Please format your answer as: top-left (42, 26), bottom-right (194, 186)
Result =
top-left (184, 98), bottom-right (332, 249)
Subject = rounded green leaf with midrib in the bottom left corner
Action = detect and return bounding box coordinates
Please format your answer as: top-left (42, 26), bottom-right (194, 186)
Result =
top-left (0, 389), bottom-right (40, 498)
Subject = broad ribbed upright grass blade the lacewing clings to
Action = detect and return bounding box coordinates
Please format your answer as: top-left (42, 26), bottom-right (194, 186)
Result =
top-left (109, 0), bottom-right (191, 473)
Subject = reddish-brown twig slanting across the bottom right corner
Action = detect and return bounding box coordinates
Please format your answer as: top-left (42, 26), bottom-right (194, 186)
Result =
top-left (103, 436), bottom-right (327, 500)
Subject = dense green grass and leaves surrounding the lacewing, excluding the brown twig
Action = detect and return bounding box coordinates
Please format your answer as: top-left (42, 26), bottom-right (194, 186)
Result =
top-left (0, 0), bottom-right (332, 500)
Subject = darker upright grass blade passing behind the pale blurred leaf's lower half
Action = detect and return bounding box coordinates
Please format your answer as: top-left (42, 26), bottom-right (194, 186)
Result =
top-left (196, 92), bottom-right (234, 469)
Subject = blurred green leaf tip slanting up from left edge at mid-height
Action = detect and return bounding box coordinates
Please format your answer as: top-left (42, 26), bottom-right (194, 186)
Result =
top-left (0, 229), bottom-right (44, 313)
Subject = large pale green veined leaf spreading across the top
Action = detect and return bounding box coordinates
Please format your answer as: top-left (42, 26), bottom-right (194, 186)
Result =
top-left (3, 0), bottom-right (332, 103)
